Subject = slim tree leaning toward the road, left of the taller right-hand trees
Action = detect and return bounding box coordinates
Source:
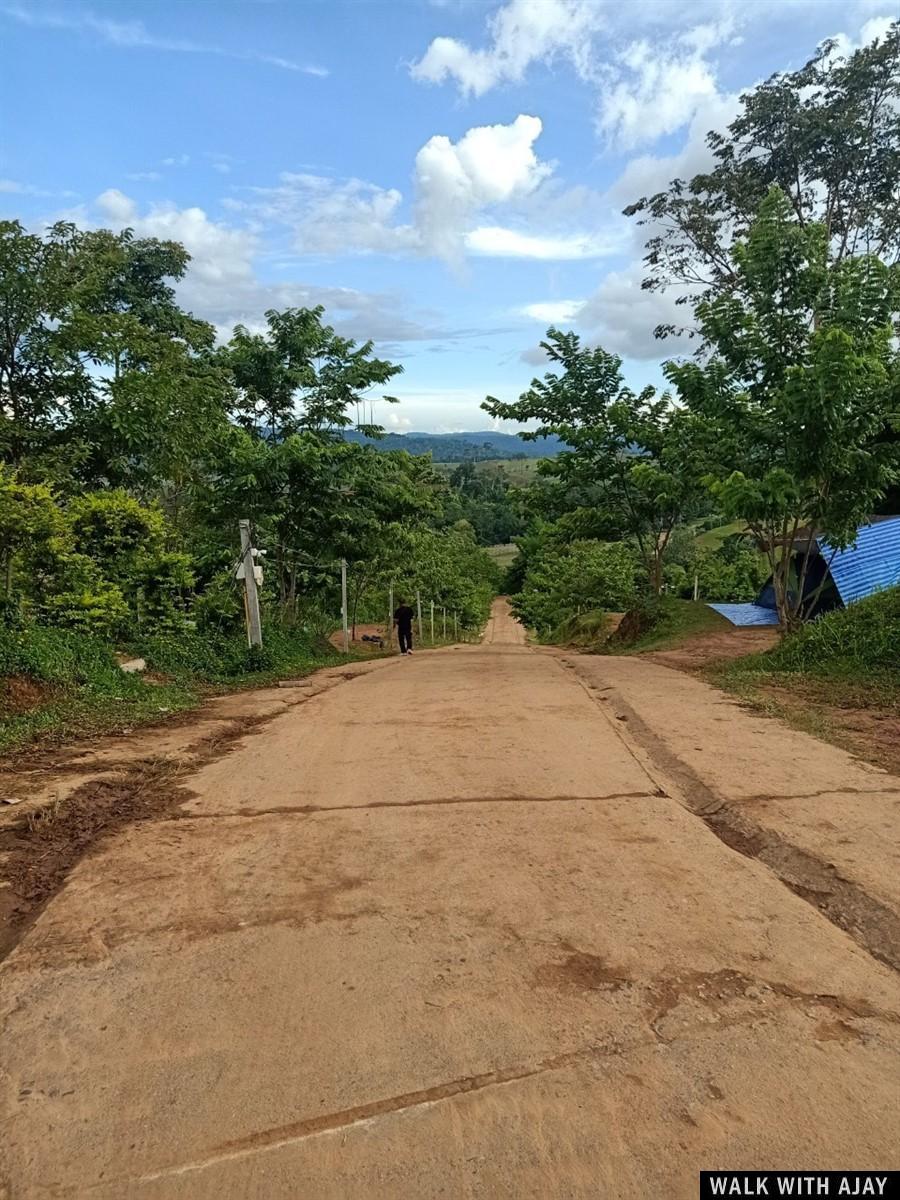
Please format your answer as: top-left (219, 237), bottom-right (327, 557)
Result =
top-left (481, 329), bottom-right (700, 592)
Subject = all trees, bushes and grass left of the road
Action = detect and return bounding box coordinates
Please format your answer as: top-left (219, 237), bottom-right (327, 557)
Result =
top-left (0, 230), bottom-right (496, 749)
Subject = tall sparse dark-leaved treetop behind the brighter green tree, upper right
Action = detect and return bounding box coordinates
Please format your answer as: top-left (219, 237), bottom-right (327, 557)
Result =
top-left (625, 23), bottom-right (900, 336)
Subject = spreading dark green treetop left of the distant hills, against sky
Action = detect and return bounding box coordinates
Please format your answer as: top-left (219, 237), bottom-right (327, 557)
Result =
top-left (222, 306), bottom-right (403, 442)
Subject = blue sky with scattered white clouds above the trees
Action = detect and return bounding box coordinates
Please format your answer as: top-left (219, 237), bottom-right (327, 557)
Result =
top-left (0, 0), bottom-right (894, 432)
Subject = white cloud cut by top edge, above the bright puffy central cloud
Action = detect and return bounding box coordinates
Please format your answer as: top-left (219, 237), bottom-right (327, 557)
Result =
top-left (410, 0), bottom-right (602, 96)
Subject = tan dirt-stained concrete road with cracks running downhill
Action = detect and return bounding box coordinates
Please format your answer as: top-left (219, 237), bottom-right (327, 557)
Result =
top-left (0, 601), bottom-right (900, 1200)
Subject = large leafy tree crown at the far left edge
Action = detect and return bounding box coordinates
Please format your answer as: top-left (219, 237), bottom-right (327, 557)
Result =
top-left (0, 222), bottom-right (228, 493)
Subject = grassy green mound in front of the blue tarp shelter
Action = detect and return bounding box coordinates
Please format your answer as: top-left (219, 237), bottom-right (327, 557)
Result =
top-left (760, 587), bottom-right (900, 672)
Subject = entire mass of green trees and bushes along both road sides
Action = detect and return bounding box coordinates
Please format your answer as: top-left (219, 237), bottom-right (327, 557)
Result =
top-left (0, 25), bottom-right (900, 758)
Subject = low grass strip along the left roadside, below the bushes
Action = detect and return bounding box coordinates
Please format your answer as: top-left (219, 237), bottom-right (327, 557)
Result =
top-left (0, 626), bottom-right (359, 752)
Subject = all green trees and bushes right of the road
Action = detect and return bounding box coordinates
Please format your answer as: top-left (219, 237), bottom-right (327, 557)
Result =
top-left (494, 25), bottom-right (900, 671)
